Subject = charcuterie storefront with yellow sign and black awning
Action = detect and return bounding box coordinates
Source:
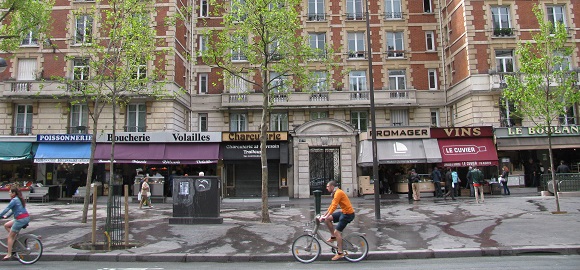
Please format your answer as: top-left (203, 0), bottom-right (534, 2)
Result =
top-left (221, 132), bottom-right (288, 197)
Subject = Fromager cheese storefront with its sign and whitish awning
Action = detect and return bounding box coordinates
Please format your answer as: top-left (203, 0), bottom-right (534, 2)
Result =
top-left (358, 127), bottom-right (442, 195)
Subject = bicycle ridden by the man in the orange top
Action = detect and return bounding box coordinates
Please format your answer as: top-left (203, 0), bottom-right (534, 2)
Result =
top-left (292, 215), bottom-right (369, 263)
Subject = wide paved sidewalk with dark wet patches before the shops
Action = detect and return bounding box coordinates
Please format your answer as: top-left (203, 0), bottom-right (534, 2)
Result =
top-left (12, 188), bottom-right (580, 262)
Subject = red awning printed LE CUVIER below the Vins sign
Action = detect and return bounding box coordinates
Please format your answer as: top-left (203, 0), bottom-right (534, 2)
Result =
top-left (438, 138), bottom-right (498, 167)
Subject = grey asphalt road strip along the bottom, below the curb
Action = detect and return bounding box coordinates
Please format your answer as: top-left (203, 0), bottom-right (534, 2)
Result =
top-left (0, 255), bottom-right (580, 270)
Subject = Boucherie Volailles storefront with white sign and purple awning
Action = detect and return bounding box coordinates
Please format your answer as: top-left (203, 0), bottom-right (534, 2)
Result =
top-left (95, 132), bottom-right (221, 197)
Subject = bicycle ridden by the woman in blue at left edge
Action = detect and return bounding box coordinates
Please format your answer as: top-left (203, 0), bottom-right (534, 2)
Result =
top-left (0, 225), bottom-right (42, 265)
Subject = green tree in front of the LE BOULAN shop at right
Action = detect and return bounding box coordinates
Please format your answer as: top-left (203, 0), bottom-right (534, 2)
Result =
top-left (503, 5), bottom-right (580, 212)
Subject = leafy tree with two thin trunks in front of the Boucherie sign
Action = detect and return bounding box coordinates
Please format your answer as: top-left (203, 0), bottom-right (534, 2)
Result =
top-left (57, 0), bottom-right (181, 223)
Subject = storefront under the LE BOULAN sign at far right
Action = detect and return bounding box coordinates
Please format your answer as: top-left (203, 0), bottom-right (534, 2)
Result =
top-left (495, 125), bottom-right (580, 187)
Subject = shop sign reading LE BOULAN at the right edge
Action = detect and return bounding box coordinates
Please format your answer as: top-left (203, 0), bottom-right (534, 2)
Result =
top-left (495, 126), bottom-right (580, 138)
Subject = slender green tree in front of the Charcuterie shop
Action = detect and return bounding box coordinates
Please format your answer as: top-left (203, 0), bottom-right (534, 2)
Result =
top-left (202, 0), bottom-right (333, 223)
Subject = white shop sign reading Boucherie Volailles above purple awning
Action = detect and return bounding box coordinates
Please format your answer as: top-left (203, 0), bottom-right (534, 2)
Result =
top-left (97, 132), bottom-right (221, 143)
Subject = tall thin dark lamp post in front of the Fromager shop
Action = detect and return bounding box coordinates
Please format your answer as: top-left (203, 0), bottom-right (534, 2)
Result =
top-left (365, 0), bottom-right (381, 219)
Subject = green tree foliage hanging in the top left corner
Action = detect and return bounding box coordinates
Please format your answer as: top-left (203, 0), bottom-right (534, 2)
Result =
top-left (0, 0), bottom-right (54, 52)
